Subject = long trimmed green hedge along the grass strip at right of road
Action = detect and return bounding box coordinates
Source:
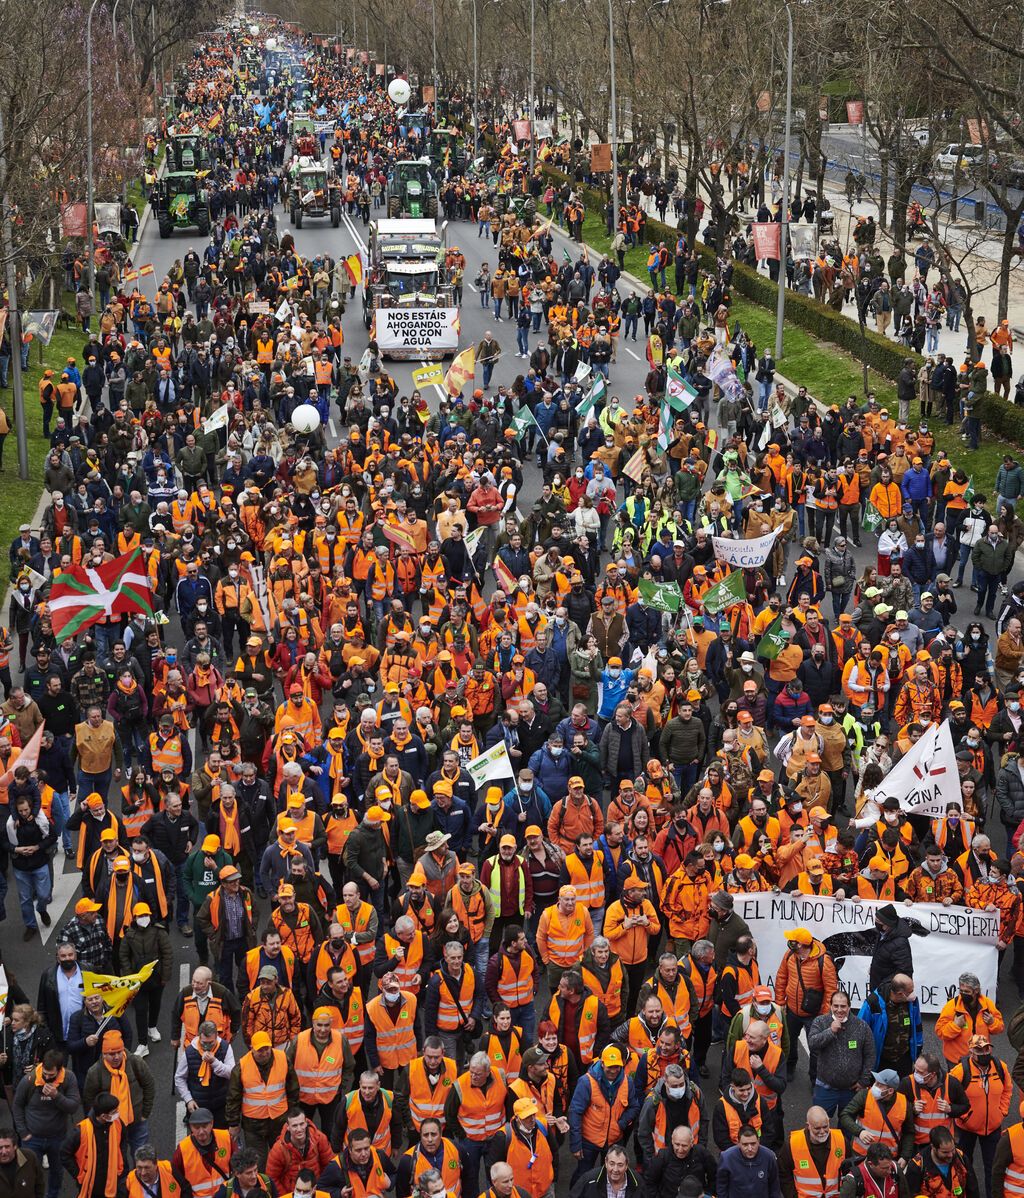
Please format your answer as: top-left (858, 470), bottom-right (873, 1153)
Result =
top-left (543, 167), bottom-right (1024, 446)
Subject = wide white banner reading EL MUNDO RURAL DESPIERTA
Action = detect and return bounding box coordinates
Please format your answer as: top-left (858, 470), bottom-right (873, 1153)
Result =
top-left (734, 891), bottom-right (1000, 1015)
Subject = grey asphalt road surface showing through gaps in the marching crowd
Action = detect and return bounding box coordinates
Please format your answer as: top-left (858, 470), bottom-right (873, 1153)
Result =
top-left (0, 149), bottom-right (1017, 1156)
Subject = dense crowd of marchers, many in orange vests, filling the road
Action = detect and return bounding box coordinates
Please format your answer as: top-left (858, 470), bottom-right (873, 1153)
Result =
top-left (10, 16), bottom-right (1024, 1198)
